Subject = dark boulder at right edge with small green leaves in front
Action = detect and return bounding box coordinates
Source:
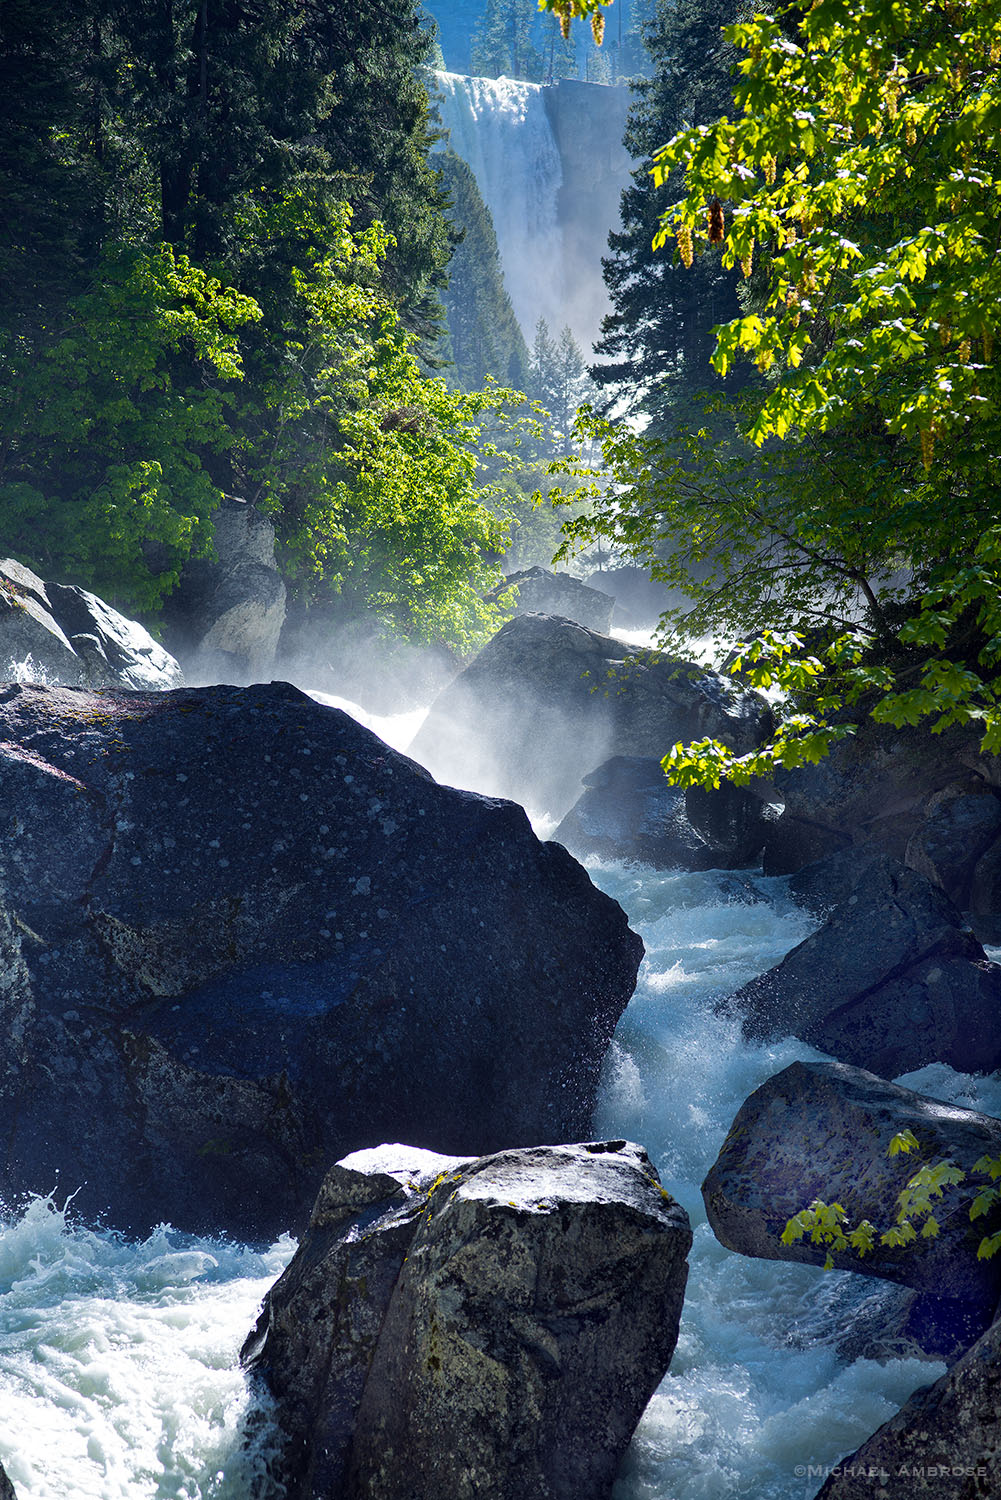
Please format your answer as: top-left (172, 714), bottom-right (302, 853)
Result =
top-left (702, 1062), bottom-right (1001, 1317)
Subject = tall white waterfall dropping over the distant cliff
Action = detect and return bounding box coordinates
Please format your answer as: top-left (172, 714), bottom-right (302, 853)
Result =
top-left (434, 72), bottom-right (566, 342)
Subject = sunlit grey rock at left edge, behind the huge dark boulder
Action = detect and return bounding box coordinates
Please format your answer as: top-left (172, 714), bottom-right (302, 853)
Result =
top-left (0, 558), bottom-right (183, 692)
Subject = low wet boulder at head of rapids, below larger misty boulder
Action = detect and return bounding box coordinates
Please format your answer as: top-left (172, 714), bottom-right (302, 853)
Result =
top-left (552, 756), bottom-right (767, 870)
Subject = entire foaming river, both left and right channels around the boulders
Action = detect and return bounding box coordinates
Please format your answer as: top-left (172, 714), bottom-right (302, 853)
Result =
top-left (0, 705), bottom-right (1001, 1500)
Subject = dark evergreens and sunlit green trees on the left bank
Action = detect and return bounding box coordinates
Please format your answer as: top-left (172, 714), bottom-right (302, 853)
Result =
top-left (0, 0), bottom-right (531, 644)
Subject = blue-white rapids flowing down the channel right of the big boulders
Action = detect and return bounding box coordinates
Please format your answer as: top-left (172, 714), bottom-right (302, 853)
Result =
top-left (590, 864), bottom-right (954, 1500)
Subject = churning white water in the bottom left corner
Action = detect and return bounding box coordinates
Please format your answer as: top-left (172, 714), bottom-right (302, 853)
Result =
top-left (0, 1199), bottom-right (294, 1500)
